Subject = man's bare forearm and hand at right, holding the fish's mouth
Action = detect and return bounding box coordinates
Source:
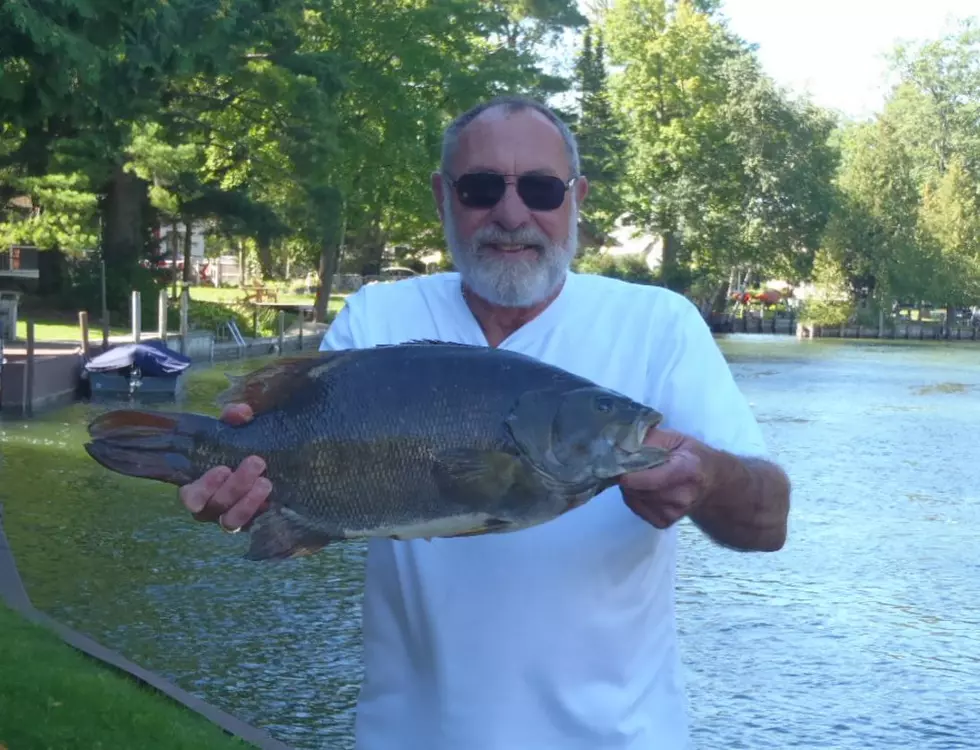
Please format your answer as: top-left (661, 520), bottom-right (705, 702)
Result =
top-left (619, 430), bottom-right (790, 551)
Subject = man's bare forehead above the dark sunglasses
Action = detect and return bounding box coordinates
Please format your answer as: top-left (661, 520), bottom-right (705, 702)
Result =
top-left (455, 107), bottom-right (569, 172)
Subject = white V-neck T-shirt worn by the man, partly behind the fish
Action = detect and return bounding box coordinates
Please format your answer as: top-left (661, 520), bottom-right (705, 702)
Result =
top-left (321, 273), bottom-right (766, 750)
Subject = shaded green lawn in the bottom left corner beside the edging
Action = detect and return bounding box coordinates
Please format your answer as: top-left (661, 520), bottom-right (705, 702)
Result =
top-left (0, 604), bottom-right (252, 750)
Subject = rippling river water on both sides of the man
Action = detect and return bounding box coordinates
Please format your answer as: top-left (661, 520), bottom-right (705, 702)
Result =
top-left (0, 336), bottom-right (980, 750)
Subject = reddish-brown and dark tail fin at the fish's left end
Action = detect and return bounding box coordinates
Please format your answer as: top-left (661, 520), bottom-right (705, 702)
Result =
top-left (85, 409), bottom-right (220, 485)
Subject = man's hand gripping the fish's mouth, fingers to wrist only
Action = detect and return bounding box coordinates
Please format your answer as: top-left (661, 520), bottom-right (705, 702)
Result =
top-left (619, 430), bottom-right (714, 529)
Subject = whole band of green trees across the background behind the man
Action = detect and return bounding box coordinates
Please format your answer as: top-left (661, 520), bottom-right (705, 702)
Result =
top-left (0, 0), bottom-right (980, 319)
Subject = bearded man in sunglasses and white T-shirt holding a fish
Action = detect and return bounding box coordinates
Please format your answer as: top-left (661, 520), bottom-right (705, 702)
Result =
top-left (181, 100), bottom-right (789, 750)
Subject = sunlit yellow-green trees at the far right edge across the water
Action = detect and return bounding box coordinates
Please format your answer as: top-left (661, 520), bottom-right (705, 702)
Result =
top-left (823, 16), bottom-right (980, 310)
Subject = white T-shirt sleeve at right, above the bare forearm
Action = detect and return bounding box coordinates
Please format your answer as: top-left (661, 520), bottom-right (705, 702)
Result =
top-left (657, 300), bottom-right (768, 457)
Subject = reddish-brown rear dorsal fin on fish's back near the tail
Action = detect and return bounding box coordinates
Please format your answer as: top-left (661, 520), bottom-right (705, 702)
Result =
top-left (215, 350), bottom-right (347, 416)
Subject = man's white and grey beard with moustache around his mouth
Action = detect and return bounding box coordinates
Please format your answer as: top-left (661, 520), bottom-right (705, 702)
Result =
top-left (443, 191), bottom-right (578, 307)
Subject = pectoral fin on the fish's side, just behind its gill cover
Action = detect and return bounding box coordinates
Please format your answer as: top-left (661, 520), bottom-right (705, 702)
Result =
top-left (433, 448), bottom-right (522, 508)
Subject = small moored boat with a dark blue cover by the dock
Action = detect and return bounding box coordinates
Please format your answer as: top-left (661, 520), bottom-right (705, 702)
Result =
top-left (82, 341), bottom-right (191, 398)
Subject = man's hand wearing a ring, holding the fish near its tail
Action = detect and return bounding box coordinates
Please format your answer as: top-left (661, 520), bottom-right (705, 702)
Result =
top-left (180, 404), bottom-right (272, 532)
